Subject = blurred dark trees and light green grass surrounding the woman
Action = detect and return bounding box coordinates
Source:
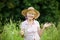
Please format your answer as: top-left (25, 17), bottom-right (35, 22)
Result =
top-left (0, 0), bottom-right (60, 40)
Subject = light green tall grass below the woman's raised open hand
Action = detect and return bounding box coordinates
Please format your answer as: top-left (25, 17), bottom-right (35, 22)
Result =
top-left (41, 25), bottom-right (58, 40)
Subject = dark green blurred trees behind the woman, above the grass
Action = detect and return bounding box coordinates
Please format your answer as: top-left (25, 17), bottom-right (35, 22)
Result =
top-left (0, 0), bottom-right (60, 24)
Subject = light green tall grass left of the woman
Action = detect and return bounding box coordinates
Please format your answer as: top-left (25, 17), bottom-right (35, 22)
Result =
top-left (1, 21), bottom-right (23, 40)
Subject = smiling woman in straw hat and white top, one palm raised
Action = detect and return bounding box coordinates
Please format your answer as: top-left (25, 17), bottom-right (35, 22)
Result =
top-left (20, 7), bottom-right (51, 40)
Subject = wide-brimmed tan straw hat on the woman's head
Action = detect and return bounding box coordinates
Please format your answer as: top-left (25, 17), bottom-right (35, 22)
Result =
top-left (22, 7), bottom-right (40, 19)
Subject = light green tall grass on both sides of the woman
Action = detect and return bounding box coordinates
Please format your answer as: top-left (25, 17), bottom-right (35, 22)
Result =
top-left (0, 21), bottom-right (60, 40)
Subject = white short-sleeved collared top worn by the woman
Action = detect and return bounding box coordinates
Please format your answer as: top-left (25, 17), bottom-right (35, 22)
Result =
top-left (20, 20), bottom-right (40, 40)
